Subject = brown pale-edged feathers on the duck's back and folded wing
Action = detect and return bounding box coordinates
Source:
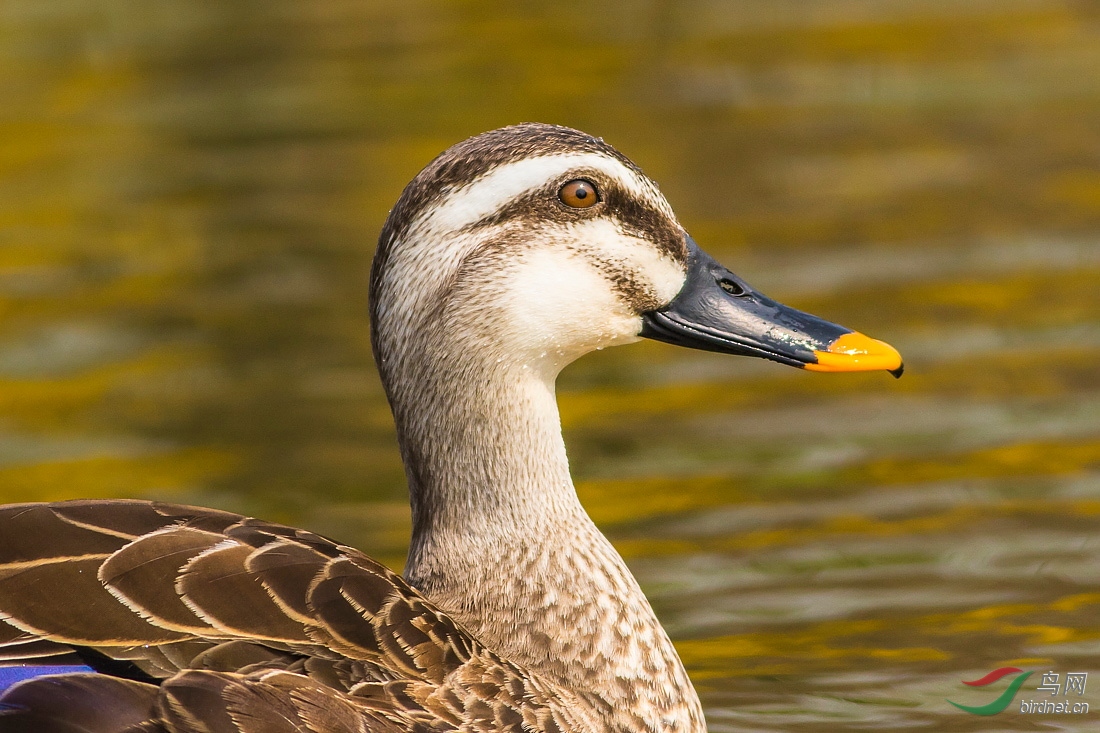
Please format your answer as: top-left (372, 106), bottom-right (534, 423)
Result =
top-left (0, 501), bottom-right (598, 733)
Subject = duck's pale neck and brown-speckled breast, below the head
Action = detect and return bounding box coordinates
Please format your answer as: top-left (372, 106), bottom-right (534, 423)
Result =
top-left (383, 349), bottom-right (705, 732)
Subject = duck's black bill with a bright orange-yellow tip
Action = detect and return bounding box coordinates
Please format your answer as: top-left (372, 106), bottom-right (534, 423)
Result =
top-left (640, 237), bottom-right (903, 376)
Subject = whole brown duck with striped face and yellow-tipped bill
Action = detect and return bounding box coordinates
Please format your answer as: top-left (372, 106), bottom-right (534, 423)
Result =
top-left (0, 123), bottom-right (902, 733)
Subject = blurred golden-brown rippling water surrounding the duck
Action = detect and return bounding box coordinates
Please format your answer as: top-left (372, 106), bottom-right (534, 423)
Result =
top-left (0, 0), bottom-right (1100, 731)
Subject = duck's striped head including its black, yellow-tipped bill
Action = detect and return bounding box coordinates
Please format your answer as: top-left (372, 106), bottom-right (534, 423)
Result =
top-left (371, 123), bottom-right (902, 378)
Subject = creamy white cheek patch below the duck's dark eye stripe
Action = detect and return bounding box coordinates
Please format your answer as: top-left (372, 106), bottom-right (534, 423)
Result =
top-left (499, 249), bottom-right (641, 367)
